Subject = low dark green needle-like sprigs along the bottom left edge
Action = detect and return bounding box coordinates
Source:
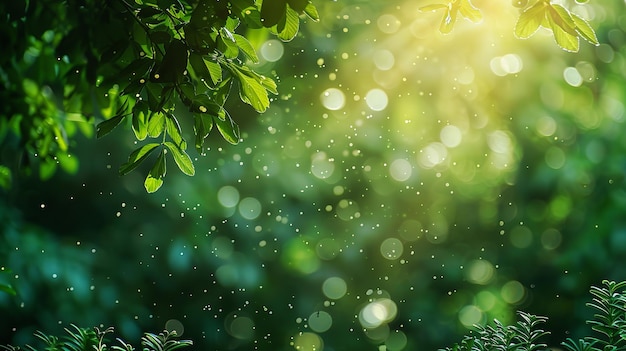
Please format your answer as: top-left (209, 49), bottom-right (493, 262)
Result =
top-left (0, 325), bottom-right (193, 351)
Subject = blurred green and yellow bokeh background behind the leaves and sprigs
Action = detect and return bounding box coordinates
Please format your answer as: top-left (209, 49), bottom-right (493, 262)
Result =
top-left (0, 0), bottom-right (626, 351)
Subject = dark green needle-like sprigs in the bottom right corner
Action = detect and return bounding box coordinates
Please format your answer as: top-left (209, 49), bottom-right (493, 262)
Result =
top-left (440, 280), bottom-right (626, 351)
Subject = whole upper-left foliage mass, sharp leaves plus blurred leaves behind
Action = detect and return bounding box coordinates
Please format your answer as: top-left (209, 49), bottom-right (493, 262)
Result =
top-left (0, 0), bottom-right (319, 192)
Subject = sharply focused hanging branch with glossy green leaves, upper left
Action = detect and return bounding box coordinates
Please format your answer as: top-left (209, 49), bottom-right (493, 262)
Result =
top-left (97, 0), bottom-right (318, 192)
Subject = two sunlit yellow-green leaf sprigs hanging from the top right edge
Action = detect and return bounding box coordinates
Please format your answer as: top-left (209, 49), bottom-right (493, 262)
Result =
top-left (420, 0), bottom-right (599, 52)
